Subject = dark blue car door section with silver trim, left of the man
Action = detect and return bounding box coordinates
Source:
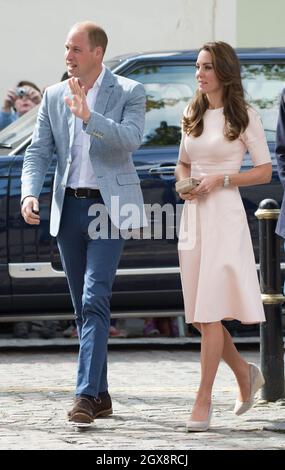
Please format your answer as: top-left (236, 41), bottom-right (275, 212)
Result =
top-left (7, 154), bottom-right (71, 313)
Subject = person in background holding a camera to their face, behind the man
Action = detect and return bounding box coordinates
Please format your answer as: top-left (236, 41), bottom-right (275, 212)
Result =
top-left (0, 80), bottom-right (42, 130)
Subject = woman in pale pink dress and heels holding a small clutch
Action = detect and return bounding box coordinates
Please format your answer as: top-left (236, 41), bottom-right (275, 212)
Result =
top-left (175, 42), bottom-right (272, 431)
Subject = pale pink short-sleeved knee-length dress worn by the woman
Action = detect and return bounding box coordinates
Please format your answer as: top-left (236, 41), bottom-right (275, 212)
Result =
top-left (178, 108), bottom-right (271, 323)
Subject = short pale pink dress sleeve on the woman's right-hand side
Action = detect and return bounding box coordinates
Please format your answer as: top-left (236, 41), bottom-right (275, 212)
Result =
top-left (241, 108), bottom-right (271, 166)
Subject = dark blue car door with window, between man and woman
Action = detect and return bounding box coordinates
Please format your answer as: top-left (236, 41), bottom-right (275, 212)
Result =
top-left (109, 60), bottom-right (196, 307)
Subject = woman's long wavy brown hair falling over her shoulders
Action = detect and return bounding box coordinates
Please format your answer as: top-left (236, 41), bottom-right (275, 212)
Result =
top-left (182, 41), bottom-right (249, 140)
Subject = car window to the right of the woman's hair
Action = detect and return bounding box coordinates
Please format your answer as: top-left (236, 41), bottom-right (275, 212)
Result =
top-left (241, 64), bottom-right (285, 142)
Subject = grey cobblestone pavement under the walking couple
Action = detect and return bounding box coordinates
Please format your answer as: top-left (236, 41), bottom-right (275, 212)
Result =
top-left (0, 348), bottom-right (285, 450)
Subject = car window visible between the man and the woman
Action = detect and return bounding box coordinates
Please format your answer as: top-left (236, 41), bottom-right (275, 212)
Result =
top-left (128, 64), bottom-right (196, 146)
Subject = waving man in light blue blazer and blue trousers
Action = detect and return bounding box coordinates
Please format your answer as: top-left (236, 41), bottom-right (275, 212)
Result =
top-left (21, 22), bottom-right (146, 426)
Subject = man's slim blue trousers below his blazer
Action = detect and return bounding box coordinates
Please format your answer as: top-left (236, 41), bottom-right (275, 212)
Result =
top-left (57, 196), bottom-right (124, 397)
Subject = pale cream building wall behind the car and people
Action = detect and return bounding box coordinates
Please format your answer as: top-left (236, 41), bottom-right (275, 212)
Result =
top-left (0, 0), bottom-right (285, 98)
